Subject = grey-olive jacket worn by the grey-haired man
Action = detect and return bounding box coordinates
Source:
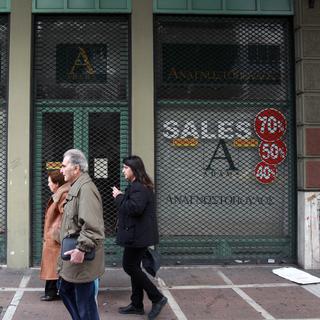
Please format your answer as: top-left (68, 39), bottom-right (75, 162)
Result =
top-left (58, 173), bottom-right (105, 283)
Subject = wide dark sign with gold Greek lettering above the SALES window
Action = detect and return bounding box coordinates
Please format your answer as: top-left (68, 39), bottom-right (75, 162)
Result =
top-left (162, 43), bottom-right (280, 85)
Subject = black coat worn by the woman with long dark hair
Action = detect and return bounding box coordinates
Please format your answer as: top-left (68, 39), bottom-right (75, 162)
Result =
top-left (115, 181), bottom-right (159, 248)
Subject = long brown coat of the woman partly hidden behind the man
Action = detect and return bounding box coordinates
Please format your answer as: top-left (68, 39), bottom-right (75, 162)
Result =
top-left (40, 183), bottom-right (70, 280)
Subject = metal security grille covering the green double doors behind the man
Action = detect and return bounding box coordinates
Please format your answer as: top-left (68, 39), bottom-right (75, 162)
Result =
top-left (33, 15), bottom-right (130, 265)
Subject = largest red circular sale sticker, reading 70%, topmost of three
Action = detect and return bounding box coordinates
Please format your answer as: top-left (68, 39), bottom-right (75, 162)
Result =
top-left (254, 108), bottom-right (287, 141)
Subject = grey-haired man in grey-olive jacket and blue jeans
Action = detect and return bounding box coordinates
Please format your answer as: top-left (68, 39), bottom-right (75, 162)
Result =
top-left (58, 149), bottom-right (104, 320)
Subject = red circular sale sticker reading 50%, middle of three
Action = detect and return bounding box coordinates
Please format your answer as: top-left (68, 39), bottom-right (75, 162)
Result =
top-left (259, 140), bottom-right (287, 165)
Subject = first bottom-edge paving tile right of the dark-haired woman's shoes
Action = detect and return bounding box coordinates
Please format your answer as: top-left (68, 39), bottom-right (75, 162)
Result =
top-left (170, 289), bottom-right (263, 320)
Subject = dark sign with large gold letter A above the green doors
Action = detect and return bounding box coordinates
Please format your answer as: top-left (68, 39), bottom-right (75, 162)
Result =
top-left (56, 44), bottom-right (107, 83)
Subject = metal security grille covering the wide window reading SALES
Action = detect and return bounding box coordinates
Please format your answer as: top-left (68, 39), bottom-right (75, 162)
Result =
top-left (155, 15), bottom-right (295, 263)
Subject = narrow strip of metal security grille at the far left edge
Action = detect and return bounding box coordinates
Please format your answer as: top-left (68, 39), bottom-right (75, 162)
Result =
top-left (0, 15), bottom-right (9, 264)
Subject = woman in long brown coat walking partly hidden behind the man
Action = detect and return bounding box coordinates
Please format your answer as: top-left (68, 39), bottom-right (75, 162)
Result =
top-left (40, 170), bottom-right (70, 301)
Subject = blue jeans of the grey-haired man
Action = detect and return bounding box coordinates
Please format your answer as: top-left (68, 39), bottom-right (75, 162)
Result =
top-left (58, 278), bottom-right (100, 320)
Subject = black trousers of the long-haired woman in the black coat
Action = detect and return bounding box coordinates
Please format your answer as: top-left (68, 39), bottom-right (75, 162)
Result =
top-left (122, 247), bottom-right (163, 308)
